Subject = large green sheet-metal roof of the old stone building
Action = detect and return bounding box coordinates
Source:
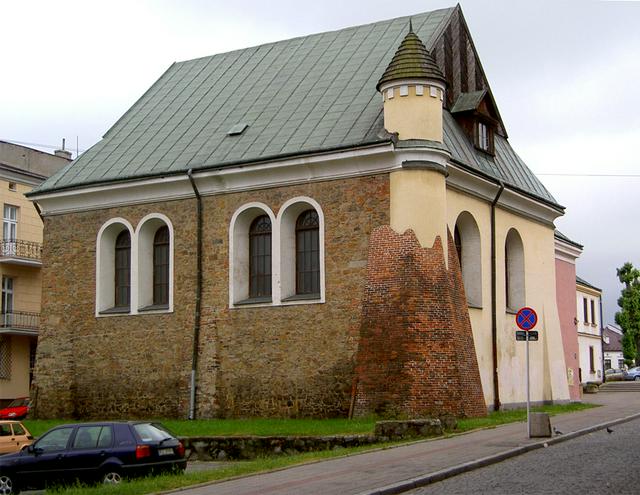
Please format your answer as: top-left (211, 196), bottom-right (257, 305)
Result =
top-left (32, 7), bottom-right (561, 209)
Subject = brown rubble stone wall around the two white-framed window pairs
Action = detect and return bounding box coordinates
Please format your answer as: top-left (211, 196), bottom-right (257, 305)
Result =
top-left (33, 175), bottom-right (389, 418)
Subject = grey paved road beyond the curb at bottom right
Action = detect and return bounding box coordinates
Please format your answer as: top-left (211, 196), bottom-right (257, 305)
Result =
top-left (406, 420), bottom-right (640, 495)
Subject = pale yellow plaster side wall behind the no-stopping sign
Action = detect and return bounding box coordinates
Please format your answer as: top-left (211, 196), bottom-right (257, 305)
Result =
top-left (447, 189), bottom-right (569, 405)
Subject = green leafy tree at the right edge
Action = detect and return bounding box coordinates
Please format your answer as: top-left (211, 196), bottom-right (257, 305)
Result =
top-left (616, 262), bottom-right (640, 365)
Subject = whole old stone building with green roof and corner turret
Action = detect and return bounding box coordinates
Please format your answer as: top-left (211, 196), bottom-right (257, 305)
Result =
top-left (30, 7), bottom-right (570, 417)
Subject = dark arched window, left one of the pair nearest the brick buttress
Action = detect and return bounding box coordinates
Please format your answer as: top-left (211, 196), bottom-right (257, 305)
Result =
top-left (249, 215), bottom-right (271, 298)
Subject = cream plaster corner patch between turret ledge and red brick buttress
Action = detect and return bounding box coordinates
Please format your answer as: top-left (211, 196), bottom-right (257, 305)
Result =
top-left (390, 169), bottom-right (447, 259)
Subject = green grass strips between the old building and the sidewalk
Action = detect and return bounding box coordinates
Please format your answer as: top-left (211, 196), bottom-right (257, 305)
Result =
top-left (24, 403), bottom-right (597, 495)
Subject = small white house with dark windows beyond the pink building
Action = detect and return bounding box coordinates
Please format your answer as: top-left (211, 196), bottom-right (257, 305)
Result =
top-left (576, 277), bottom-right (604, 383)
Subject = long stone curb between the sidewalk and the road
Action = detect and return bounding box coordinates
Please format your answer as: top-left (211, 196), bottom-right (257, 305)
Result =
top-left (357, 413), bottom-right (640, 495)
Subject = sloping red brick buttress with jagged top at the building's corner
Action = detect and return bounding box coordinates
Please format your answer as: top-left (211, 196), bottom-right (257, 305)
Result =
top-left (355, 226), bottom-right (486, 417)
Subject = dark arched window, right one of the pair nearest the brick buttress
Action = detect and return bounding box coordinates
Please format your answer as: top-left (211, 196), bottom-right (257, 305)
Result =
top-left (296, 210), bottom-right (320, 294)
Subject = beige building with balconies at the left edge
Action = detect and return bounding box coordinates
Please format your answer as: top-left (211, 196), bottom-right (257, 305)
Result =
top-left (0, 141), bottom-right (70, 405)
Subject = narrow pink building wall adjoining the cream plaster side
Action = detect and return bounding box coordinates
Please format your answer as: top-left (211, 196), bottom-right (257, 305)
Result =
top-left (555, 230), bottom-right (582, 401)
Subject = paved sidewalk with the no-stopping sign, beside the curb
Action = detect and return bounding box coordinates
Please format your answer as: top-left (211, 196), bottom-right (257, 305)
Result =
top-left (172, 392), bottom-right (640, 495)
